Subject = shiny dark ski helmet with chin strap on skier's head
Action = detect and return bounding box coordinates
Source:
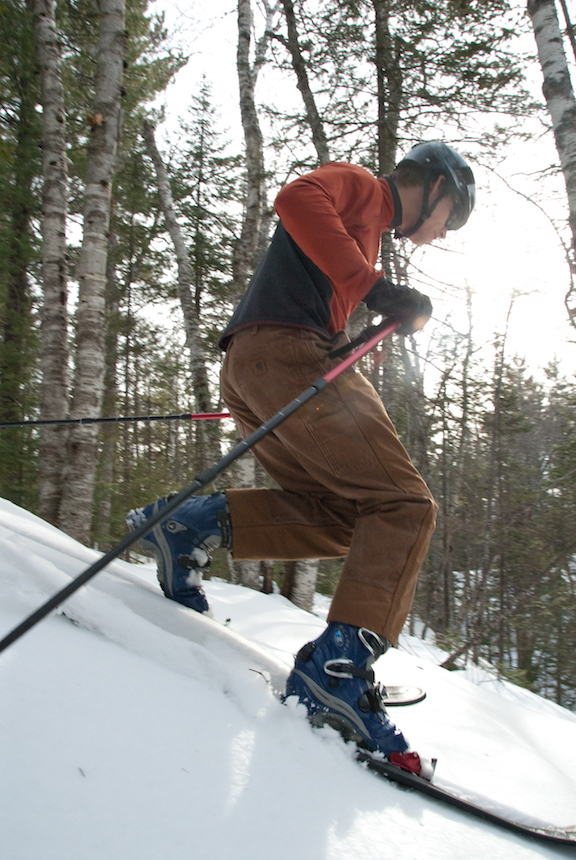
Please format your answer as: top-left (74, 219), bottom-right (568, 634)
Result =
top-left (398, 140), bottom-right (476, 235)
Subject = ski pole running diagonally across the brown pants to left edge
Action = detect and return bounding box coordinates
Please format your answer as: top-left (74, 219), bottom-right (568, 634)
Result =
top-left (0, 322), bottom-right (398, 652)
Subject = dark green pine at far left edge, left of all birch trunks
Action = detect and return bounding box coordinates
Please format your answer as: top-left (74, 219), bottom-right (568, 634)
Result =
top-left (0, 2), bottom-right (41, 506)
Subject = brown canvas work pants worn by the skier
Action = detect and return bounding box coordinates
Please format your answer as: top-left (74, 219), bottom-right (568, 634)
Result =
top-left (221, 326), bottom-right (437, 644)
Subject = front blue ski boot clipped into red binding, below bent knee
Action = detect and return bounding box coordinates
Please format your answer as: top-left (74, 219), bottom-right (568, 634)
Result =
top-left (286, 623), bottom-right (419, 772)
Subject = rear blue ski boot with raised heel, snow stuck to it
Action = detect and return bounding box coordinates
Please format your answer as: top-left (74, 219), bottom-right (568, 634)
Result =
top-left (126, 493), bottom-right (232, 613)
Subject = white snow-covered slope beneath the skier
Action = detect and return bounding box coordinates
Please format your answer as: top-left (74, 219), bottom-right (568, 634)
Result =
top-left (0, 501), bottom-right (576, 860)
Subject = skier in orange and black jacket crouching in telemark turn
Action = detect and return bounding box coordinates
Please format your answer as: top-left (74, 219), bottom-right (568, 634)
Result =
top-left (128, 141), bottom-right (475, 773)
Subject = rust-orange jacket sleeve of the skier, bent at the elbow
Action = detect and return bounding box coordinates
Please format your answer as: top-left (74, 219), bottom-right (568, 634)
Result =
top-left (275, 162), bottom-right (387, 302)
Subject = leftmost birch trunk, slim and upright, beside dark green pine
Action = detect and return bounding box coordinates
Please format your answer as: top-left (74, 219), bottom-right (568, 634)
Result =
top-left (34, 0), bottom-right (69, 523)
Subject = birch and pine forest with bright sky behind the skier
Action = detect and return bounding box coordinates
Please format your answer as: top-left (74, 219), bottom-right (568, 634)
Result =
top-left (0, 0), bottom-right (576, 708)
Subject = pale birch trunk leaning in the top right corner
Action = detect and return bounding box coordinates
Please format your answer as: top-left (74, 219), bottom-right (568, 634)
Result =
top-left (527, 0), bottom-right (576, 328)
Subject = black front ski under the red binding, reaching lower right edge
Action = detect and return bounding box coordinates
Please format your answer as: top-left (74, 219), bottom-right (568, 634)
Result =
top-left (357, 749), bottom-right (576, 847)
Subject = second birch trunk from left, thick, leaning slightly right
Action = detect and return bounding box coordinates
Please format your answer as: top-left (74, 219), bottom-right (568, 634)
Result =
top-left (60, 0), bottom-right (126, 543)
